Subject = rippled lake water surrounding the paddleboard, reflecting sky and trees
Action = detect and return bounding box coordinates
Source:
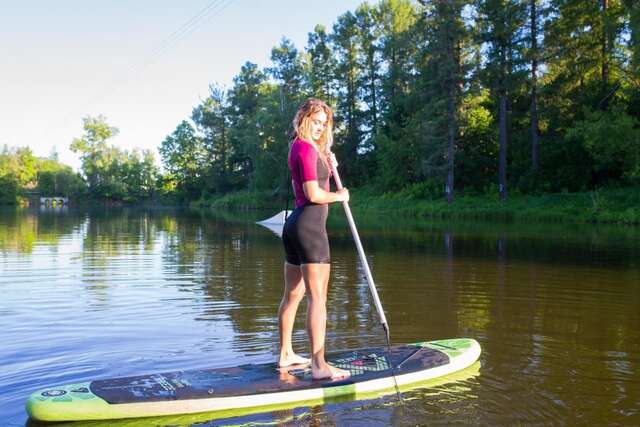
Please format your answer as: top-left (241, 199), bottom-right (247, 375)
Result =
top-left (0, 209), bottom-right (640, 426)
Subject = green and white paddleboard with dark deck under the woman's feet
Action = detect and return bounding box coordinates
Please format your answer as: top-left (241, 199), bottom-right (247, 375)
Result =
top-left (26, 338), bottom-right (480, 421)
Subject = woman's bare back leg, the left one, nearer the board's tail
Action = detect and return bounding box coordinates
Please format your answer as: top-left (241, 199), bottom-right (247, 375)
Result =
top-left (278, 262), bottom-right (309, 368)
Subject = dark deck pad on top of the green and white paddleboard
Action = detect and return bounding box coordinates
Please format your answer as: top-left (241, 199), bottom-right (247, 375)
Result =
top-left (90, 345), bottom-right (449, 404)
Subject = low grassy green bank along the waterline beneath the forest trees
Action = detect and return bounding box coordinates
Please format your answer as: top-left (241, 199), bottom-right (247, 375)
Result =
top-left (193, 188), bottom-right (640, 225)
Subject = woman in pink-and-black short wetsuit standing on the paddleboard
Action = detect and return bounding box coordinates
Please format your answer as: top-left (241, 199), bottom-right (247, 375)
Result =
top-left (278, 99), bottom-right (349, 379)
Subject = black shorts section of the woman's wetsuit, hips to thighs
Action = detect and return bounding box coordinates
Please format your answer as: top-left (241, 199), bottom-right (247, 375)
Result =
top-left (282, 205), bottom-right (331, 265)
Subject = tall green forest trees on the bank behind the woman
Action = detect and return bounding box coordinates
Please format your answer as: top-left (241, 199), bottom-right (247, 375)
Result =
top-left (148, 0), bottom-right (640, 215)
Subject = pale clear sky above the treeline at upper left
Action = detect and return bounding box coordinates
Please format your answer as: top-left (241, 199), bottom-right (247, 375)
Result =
top-left (0, 0), bottom-right (363, 169)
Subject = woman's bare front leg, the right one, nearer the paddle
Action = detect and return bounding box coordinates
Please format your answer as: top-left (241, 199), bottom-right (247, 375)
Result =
top-left (301, 264), bottom-right (349, 379)
